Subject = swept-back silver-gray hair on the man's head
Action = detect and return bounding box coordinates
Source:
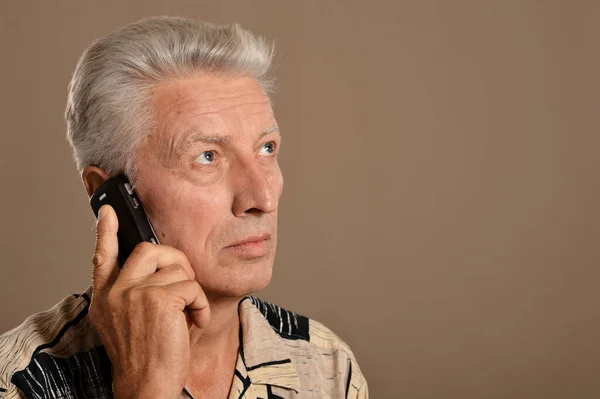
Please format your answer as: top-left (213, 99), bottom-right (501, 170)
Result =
top-left (65, 16), bottom-right (275, 178)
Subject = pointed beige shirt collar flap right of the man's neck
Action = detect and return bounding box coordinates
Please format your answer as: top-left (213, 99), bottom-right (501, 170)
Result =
top-left (238, 296), bottom-right (300, 392)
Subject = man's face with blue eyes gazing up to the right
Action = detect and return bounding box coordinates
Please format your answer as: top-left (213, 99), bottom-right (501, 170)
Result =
top-left (136, 75), bottom-right (283, 296)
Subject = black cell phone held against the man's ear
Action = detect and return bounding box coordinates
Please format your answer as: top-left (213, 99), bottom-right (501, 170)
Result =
top-left (90, 174), bottom-right (159, 267)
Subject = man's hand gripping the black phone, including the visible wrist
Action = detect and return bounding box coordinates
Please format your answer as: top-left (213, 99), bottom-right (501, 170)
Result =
top-left (89, 205), bottom-right (210, 398)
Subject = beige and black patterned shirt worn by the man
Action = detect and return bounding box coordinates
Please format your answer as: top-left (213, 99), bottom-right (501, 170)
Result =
top-left (0, 287), bottom-right (368, 399)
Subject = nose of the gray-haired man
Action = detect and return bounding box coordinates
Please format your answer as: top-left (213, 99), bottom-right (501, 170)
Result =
top-left (232, 162), bottom-right (281, 217)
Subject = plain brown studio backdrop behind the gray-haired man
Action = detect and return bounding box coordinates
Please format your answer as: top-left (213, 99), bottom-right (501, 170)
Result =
top-left (0, 0), bottom-right (600, 398)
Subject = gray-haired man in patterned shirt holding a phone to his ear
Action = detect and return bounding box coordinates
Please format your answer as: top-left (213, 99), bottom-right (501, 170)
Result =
top-left (0, 17), bottom-right (368, 399)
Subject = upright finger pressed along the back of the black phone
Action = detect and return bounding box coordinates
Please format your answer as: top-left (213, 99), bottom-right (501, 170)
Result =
top-left (92, 205), bottom-right (119, 291)
